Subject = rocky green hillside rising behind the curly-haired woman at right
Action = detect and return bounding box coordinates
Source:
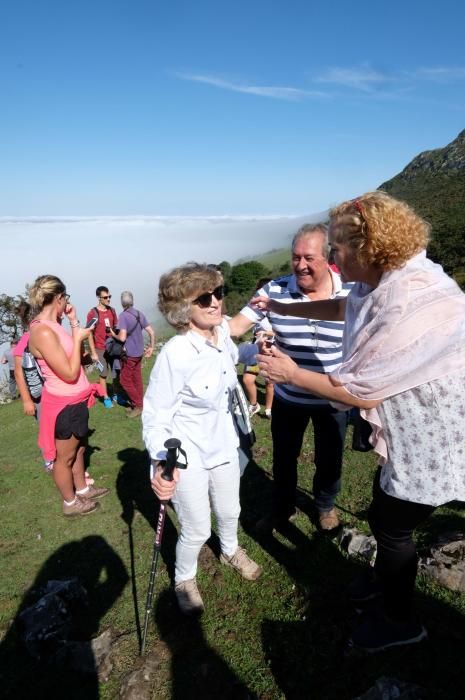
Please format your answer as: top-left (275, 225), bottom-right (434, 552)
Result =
top-left (379, 129), bottom-right (465, 287)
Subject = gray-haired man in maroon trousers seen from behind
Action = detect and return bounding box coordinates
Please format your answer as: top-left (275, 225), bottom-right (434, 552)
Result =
top-left (117, 292), bottom-right (155, 418)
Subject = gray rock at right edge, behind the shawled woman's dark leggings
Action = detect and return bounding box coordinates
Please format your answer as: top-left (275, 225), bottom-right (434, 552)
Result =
top-left (419, 532), bottom-right (465, 592)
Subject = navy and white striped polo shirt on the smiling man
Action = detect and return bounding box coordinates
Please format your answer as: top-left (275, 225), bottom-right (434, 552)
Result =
top-left (241, 269), bottom-right (353, 406)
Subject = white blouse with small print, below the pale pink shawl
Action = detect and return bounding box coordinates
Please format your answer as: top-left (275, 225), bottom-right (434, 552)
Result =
top-left (378, 373), bottom-right (465, 506)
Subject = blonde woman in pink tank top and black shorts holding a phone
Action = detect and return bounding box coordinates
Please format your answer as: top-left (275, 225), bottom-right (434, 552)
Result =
top-left (29, 275), bottom-right (108, 516)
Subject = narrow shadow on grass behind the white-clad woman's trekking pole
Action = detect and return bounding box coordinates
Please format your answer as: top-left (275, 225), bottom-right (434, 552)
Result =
top-left (116, 447), bottom-right (177, 648)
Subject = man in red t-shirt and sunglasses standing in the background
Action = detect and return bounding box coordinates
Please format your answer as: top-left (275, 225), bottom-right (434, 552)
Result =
top-left (87, 285), bottom-right (118, 408)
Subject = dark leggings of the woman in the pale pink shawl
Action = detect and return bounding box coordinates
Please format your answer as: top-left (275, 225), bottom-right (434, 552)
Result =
top-left (368, 469), bottom-right (435, 621)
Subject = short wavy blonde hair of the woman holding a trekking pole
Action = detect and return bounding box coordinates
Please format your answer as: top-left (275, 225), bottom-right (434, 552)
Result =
top-left (158, 262), bottom-right (223, 332)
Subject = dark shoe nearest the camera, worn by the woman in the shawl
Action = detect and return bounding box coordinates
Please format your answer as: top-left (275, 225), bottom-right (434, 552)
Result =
top-left (349, 613), bottom-right (428, 654)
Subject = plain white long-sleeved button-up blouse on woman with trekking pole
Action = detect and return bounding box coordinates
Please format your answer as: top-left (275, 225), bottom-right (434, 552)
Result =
top-left (142, 322), bottom-right (239, 469)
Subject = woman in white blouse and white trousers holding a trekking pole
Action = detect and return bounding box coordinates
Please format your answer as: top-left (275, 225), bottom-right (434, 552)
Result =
top-left (142, 263), bottom-right (261, 614)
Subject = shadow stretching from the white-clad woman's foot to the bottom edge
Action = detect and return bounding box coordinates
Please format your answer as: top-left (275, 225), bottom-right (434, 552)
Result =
top-left (155, 589), bottom-right (257, 700)
